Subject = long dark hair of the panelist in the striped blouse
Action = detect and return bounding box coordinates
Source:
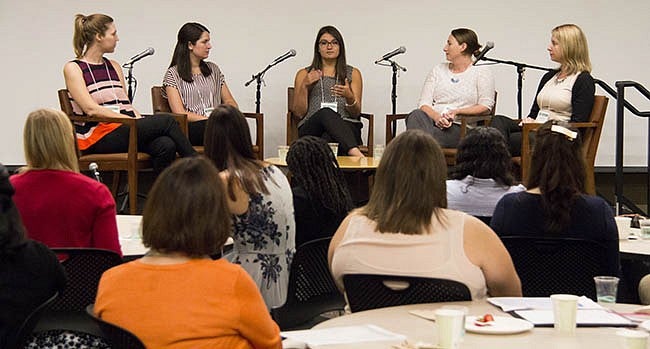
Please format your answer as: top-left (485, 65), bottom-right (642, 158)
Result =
top-left (169, 22), bottom-right (212, 82)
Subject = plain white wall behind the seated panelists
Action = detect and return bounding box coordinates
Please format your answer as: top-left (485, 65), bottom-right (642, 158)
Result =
top-left (0, 0), bottom-right (650, 166)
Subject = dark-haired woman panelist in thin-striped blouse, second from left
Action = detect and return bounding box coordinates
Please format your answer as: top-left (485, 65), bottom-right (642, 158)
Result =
top-left (163, 23), bottom-right (238, 145)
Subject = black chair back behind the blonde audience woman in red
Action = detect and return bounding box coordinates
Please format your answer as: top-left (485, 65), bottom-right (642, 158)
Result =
top-left (50, 248), bottom-right (122, 312)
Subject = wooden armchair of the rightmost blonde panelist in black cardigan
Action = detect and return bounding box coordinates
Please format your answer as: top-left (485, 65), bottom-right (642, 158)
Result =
top-left (513, 96), bottom-right (609, 195)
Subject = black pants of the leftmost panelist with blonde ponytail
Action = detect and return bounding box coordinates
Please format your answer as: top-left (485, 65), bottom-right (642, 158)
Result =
top-left (83, 114), bottom-right (196, 173)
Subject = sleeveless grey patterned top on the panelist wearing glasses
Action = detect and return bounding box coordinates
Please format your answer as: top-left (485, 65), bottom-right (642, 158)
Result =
top-left (298, 65), bottom-right (361, 127)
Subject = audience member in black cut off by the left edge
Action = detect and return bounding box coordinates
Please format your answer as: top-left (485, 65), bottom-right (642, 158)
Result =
top-left (0, 163), bottom-right (66, 348)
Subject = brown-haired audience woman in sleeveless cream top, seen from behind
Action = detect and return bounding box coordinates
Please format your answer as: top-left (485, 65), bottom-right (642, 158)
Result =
top-left (328, 130), bottom-right (521, 299)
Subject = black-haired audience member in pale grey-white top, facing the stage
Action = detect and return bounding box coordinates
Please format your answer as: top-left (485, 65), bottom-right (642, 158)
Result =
top-left (447, 127), bottom-right (526, 219)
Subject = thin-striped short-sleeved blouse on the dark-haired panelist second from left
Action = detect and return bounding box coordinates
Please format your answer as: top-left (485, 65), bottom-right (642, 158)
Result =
top-left (162, 62), bottom-right (226, 116)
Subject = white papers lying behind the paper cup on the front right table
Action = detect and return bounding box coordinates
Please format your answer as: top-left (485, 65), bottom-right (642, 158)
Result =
top-left (487, 296), bottom-right (636, 327)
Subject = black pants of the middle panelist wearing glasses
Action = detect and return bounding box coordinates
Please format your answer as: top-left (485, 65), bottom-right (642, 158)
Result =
top-left (298, 108), bottom-right (363, 155)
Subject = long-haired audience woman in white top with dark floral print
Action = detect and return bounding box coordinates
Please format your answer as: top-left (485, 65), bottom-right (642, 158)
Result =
top-left (205, 104), bottom-right (296, 309)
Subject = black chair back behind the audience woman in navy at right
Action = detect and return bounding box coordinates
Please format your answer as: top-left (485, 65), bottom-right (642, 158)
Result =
top-left (501, 236), bottom-right (608, 300)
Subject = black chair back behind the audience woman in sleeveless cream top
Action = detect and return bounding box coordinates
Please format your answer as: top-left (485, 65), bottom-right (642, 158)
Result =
top-left (343, 274), bottom-right (472, 312)
